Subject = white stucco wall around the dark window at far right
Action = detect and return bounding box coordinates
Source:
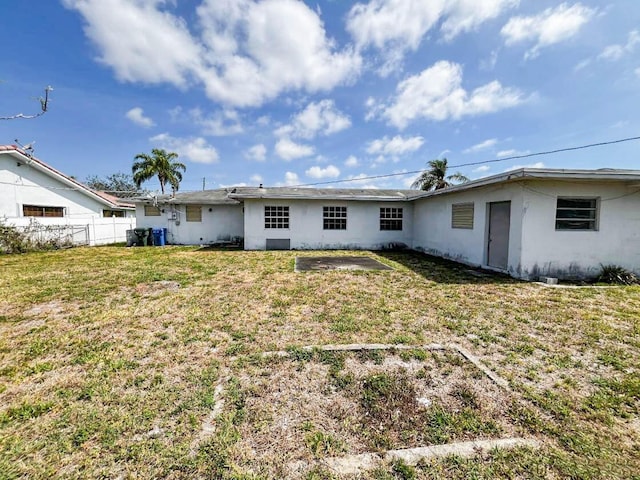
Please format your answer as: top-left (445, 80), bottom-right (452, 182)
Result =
top-left (521, 182), bottom-right (640, 279)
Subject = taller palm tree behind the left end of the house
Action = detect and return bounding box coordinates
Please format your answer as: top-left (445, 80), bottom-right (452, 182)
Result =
top-left (131, 148), bottom-right (187, 195)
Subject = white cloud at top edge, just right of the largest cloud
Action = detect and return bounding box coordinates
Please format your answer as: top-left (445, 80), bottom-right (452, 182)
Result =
top-left (347, 0), bottom-right (519, 76)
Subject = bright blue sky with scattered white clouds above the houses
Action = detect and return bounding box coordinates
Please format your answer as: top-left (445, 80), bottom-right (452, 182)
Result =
top-left (0, 0), bottom-right (640, 191)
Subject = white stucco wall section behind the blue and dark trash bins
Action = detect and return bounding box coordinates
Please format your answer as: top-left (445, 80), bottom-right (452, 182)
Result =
top-left (136, 204), bottom-right (244, 245)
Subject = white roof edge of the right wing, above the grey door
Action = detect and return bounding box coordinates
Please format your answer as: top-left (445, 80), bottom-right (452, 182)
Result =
top-left (418, 168), bottom-right (640, 198)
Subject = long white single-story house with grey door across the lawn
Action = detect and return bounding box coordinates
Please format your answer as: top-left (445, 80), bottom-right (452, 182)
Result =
top-left (135, 168), bottom-right (640, 279)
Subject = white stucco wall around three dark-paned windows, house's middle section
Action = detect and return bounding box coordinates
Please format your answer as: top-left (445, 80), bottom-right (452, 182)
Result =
top-left (244, 199), bottom-right (413, 250)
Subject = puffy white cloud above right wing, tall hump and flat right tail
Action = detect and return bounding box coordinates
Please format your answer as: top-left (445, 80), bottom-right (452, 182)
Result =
top-left (382, 61), bottom-right (523, 129)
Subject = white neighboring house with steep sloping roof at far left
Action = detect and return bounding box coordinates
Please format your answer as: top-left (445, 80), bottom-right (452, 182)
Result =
top-left (0, 145), bottom-right (135, 245)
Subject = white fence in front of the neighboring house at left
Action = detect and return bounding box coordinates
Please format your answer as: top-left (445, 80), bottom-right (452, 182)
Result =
top-left (3, 217), bottom-right (136, 245)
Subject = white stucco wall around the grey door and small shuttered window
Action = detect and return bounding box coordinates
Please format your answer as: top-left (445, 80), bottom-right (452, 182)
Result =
top-left (412, 184), bottom-right (523, 276)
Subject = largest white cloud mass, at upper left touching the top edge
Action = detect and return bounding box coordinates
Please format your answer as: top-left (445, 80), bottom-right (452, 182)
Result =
top-left (63, 0), bottom-right (362, 107)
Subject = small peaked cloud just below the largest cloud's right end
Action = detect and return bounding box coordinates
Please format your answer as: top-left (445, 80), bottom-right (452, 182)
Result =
top-left (274, 100), bottom-right (351, 139)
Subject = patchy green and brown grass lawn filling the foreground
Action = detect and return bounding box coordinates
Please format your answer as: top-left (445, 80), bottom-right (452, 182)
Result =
top-left (0, 247), bottom-right (640, 480)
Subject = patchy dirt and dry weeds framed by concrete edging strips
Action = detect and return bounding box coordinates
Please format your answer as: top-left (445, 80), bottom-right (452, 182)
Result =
top-left (228, 349), bottom-right (516, 478)
